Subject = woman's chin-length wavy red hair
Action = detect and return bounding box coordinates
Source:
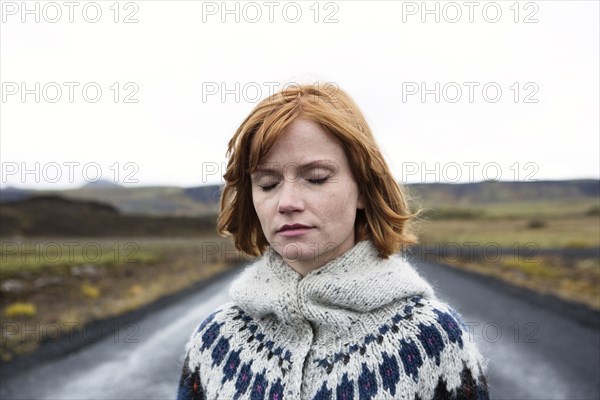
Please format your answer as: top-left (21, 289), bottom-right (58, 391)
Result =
top-left (217, 83), bottom-right (416, 258)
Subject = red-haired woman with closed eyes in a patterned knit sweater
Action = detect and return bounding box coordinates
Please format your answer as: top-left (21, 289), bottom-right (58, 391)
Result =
top-left (178, 85), bottom-right (489, 400)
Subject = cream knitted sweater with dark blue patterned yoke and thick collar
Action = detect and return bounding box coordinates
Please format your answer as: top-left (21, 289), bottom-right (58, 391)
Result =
top-left (177, 240), bottom-right (489, 400)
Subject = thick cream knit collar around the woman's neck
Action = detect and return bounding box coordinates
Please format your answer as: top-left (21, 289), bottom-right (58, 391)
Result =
top-left (229, 240), bottom-right (435, 337)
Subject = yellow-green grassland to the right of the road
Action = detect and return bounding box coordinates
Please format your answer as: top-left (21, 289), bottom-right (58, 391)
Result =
top-left (420, 215), bottom-right (600, 310)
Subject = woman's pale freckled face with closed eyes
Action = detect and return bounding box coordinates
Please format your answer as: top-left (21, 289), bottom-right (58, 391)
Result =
top-left (252, 118), bottom-right (364, 276)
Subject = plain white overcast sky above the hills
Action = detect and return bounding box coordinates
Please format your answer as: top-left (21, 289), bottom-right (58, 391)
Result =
top-left (0, 1), bottom-right (600, 189)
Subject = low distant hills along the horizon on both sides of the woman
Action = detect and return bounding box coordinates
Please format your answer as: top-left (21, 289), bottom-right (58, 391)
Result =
top-left (0, 179), bottom-right (600, 217)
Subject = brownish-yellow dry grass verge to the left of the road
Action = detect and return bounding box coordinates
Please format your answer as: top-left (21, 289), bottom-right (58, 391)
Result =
top-left (0, 237), bottom-right (246, 362)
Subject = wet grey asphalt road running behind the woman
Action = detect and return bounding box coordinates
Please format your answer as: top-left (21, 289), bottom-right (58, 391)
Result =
top-left (0, 264), bottom-right (600, 400)
